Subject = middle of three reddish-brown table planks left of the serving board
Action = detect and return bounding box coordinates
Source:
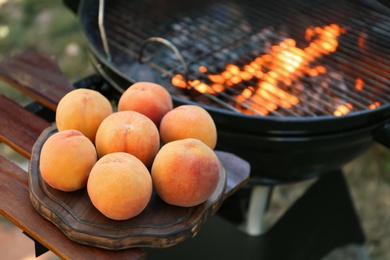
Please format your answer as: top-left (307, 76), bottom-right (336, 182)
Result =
top-left (0, 95), bottom-right (50, 159)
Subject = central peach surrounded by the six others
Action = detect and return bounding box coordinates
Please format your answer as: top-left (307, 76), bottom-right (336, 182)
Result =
top-left (95, 110), bottom-right (160, 166)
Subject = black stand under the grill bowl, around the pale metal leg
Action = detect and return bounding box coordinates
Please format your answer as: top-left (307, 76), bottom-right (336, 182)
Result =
top-left (145, 170), bottom-right (366, 260)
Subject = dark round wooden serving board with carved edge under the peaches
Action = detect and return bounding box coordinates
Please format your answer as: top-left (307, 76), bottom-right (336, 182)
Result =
top-left (29, 126), bottom-right (227, 250)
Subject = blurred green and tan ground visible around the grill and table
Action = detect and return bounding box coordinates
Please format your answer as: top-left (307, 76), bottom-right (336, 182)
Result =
top-left (0, 0), bottom-right (390, 260)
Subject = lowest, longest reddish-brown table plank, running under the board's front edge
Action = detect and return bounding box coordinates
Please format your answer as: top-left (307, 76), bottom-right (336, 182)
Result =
top-left (0, 155), bottom-right (145, 259)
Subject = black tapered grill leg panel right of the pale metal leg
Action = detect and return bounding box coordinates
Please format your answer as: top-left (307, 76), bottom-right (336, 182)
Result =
top-left (265, 170), bottom-right (365, 259)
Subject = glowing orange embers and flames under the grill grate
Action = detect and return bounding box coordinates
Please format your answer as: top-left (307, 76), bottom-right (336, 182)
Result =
top-left (172, 24), bottom-right (380, 116)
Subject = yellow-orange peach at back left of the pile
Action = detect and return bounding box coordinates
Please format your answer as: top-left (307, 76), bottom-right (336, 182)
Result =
top-left (56, 88), bottom-right (112, 142)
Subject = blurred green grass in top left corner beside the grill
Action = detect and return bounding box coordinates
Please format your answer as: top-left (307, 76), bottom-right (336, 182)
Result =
top-left (0, 0), bottom-right (93, 82)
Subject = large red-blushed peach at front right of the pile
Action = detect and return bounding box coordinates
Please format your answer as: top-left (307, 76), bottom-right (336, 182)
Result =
top-left (151, 138), bottom-right (221, 207)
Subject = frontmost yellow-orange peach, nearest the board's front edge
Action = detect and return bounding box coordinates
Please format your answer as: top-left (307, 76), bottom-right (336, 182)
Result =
top-left (87, 152), bottom-right (152, 220)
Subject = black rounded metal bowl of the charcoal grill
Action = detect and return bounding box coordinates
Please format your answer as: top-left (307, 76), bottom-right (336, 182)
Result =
top-left (79, 0), bottom-right (390, 183)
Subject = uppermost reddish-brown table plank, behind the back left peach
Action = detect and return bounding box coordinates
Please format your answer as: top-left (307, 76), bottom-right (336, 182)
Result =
top-left (0, 50), bottom-right (73, 111)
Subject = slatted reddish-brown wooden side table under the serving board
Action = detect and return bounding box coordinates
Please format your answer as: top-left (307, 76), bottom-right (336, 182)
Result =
top-left (0, 51), bottom-right (250, 259)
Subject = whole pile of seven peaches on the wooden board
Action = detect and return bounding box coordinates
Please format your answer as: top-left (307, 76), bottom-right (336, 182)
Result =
top-left (39, 82), bottom-right (221, 220)
